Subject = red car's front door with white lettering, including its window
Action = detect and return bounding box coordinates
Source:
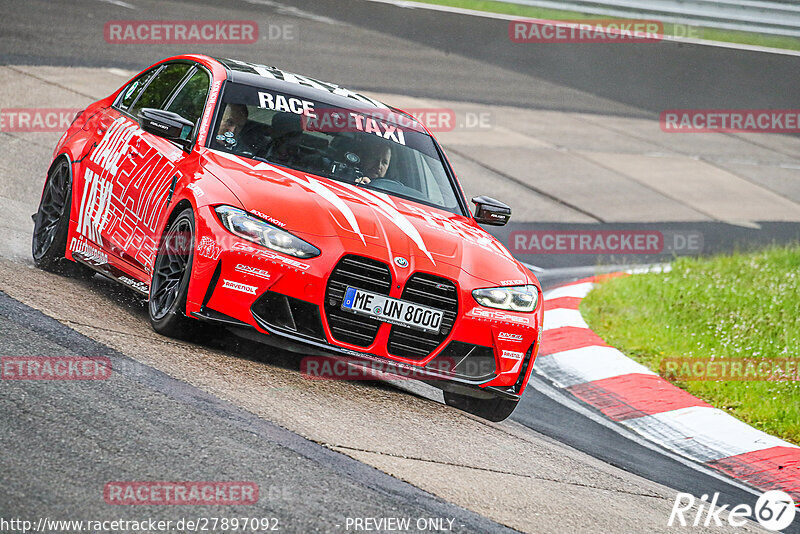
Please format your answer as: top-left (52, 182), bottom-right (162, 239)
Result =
top-left (76, 62), bottom-right (206, 279)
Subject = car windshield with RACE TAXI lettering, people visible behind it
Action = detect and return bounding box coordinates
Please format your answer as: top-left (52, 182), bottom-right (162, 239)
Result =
top-left (209, 83), bottom-right (462, 214)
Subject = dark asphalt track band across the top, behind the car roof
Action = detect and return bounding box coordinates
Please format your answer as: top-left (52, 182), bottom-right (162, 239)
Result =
top-left (0, 0), bottom-right (800, 116)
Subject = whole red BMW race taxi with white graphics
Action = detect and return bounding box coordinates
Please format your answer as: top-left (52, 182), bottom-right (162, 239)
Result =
top-left (33, 55), bottom-right (543, 420)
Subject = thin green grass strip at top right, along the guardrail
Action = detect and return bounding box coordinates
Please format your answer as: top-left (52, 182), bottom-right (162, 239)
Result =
top-left (418, 0), bottom-right (800, 50)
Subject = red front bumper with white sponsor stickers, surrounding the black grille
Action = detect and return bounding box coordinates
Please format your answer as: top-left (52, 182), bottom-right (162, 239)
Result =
top-left (187, 207), bottom-right (542, 399)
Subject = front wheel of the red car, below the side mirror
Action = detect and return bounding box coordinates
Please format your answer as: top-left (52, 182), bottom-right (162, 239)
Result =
top-left (147, 208), bottom-right (200, 339)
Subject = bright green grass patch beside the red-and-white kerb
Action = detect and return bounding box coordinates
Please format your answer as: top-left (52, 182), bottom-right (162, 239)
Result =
top-left (581, 245), bottom-right (800, 444)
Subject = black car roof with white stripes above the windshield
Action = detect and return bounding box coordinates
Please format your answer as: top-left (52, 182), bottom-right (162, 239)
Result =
top-left (214, 58), bottom-right (426, 132)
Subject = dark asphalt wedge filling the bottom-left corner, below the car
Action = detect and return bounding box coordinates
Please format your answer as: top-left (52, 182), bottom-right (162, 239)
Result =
top-left (0, 293), bottom-right (511, 532)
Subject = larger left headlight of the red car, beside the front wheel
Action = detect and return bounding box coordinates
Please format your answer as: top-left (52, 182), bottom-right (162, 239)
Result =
top-left (219, 206), bottom-right (320, 258)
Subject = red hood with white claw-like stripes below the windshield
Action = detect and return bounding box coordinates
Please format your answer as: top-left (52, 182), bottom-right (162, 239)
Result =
top-left (205, 150), bottom-right (532, 285)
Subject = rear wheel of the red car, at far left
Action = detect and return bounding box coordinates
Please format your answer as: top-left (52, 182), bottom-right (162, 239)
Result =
top-left (31, 157), bottom-right (94, 278)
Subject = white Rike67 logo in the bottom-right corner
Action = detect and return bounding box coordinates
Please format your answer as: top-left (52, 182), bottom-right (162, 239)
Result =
top-left (667, 490), bottom-right (797, 531)
